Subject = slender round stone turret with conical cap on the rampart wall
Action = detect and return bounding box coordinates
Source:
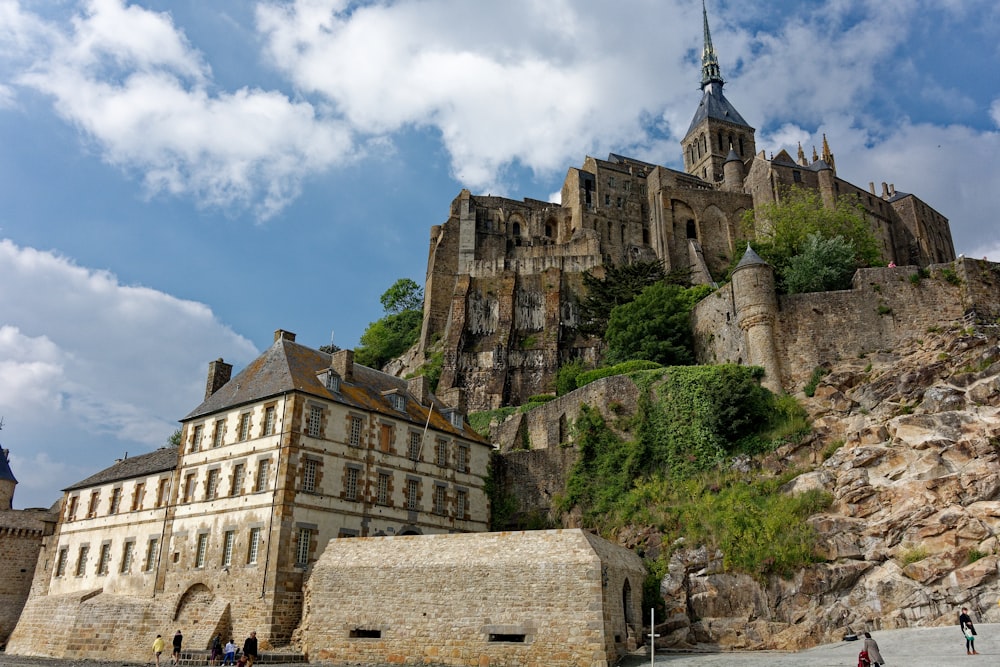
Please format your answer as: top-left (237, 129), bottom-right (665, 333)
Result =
top-left (732, 244), bottom-right (782, 393)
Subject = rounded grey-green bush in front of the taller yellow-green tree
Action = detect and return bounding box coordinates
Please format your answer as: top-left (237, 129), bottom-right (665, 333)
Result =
top-left (782, 234), bottom-right (857, 294)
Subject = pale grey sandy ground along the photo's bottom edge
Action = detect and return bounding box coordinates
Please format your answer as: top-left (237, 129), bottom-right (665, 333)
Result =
top-left (0, 623), bottom-right (1000, 667)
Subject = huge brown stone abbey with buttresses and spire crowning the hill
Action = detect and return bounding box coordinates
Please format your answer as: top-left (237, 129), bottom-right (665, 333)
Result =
top-left (415, 3), bottom-right (955, 410)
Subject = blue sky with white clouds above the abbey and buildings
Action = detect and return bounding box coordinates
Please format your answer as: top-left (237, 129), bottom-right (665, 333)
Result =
top-left (0, 0), bottom-right (1000, 508)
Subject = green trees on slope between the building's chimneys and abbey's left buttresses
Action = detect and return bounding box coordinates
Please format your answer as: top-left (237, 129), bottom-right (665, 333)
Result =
top-left (354, 278), bottom-right (424, 368)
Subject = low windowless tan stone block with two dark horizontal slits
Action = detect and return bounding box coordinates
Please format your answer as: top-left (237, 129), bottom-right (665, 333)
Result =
top-left (298, 530), bottom-right (645, 667)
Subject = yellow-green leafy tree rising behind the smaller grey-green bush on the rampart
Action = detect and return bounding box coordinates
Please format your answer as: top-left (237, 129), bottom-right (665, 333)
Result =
top-left (743, 187), bottom-right (882, 292)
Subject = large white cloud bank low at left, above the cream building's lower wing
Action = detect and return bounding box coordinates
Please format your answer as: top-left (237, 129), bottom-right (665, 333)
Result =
top-left (0, 240), bottom-right (256, 505)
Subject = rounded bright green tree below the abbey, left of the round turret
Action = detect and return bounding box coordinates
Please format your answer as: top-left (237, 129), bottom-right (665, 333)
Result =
top-left (604, 282), bottom-right (711, 366)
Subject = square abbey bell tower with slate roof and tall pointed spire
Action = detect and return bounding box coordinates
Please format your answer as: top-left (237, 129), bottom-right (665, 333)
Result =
top-left (681, 0), bottom-right (756, 183)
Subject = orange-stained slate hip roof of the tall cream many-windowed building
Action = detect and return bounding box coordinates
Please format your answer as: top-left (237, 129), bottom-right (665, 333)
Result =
top-left (181, 338), bottom-right (486, 443)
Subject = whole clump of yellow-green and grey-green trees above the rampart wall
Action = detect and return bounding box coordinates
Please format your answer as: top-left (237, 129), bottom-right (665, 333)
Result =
top-left (743, 187), bottom-right (881, 294)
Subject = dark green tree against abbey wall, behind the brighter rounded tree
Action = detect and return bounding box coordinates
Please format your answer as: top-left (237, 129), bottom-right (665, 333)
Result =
top-left (580, 260), bottom-right (666, 336)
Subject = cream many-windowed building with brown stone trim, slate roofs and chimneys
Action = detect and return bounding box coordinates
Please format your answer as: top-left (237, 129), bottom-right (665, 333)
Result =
top-left (10, 330), bottom-right (492, 659)
